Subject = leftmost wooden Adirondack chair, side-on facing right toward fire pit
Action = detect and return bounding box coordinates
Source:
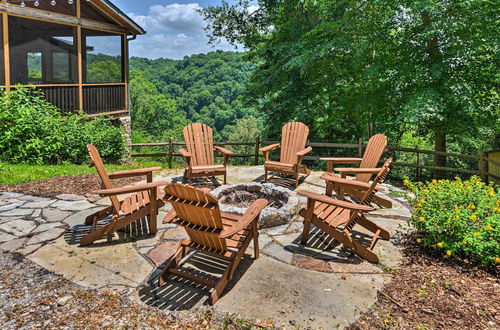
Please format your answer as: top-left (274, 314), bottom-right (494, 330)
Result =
top-left (80, 144), bottom-right (168, 246)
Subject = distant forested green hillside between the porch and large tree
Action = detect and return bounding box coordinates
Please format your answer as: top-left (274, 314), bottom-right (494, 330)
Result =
top-left (130, 51), bottom-right (259, 142)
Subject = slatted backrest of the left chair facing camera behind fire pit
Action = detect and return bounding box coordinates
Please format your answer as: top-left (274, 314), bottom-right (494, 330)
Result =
top-left (182, 123), bottom-right (214, 166)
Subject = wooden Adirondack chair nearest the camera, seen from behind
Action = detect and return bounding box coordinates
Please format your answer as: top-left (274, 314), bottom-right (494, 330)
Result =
top-left (158, 184), bottom-right (268, 304)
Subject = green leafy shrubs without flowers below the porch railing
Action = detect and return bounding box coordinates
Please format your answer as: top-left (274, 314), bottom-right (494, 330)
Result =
top-left (0, 87), bottom-right (125, 165)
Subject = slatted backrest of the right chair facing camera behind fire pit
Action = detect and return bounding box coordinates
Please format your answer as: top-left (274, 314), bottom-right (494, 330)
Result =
top-left (280, 122), bottom-right (309, 164)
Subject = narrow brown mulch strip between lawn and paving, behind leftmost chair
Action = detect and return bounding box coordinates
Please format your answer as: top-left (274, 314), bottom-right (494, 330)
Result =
top-left (0, 174), bottom-right (143, 197)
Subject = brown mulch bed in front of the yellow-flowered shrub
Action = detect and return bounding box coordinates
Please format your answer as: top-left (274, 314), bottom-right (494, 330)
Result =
top-left (350, 235), bottom-right (500, 329)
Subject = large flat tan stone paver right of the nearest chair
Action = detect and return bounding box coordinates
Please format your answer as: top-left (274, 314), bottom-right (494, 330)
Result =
top-left (214, 257), bottom-right (385, 329)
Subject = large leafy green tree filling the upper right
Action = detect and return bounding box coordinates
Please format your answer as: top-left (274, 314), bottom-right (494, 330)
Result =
top-left (203, 0), bottom-right (499, 177)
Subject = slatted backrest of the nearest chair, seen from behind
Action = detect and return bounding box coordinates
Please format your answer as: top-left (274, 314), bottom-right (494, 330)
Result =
top-left (165, 184), bottom-right (227, 251)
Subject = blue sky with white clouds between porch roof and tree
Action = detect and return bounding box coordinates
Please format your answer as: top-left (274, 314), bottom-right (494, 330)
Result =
top-left (112, 0), bottom-right (241, 59)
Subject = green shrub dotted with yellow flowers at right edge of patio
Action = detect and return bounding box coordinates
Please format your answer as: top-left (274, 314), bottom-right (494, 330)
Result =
top-left (405, 177), bottom-right (500, 266)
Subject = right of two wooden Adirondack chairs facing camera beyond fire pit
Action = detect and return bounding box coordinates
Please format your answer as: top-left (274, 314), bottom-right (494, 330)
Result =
top-left (259, 122), bottom-right (312, 187)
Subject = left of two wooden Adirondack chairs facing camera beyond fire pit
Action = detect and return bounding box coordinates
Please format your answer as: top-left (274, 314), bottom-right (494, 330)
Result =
top-left (179, 123), bottom-right (233, 184)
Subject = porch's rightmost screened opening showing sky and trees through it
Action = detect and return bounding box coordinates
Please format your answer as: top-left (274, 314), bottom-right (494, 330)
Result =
top-left (82, 30), bottom-right (123, 83)
